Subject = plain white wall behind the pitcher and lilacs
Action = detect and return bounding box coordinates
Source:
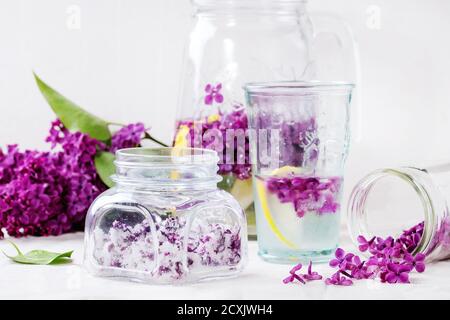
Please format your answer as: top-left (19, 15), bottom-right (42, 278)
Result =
top-left (0, 0), bottom-right (450, 210)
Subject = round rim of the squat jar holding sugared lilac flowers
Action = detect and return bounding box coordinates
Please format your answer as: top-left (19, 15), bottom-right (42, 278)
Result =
top-left (114, 147), bottom-right (219, 167)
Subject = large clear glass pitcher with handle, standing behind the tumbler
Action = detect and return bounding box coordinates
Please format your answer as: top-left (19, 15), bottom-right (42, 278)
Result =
top-left (173, 0), bottom-right (355, 235)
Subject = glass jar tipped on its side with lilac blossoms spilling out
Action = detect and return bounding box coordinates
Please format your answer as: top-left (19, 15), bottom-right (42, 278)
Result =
top-left (347, 164), bottom-right (450, 261)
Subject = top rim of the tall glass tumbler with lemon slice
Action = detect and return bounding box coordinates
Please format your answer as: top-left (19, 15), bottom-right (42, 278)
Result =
top-left (243, 80), bottom-right (355, 95)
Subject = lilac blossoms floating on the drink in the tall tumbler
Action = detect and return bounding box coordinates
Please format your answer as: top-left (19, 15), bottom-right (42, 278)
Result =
top-left (266, 175), bottom-right (342, 218)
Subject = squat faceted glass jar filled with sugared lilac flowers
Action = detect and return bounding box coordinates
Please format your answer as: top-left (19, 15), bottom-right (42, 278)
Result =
top-left (84, 148), bottom-right (247, 283)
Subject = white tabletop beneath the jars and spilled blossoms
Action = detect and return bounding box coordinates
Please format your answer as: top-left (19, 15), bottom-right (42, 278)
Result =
top-left (0, 233), bottom-right (450, 300)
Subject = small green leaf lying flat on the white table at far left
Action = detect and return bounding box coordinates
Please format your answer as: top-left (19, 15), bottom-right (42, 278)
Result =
top-left (3, 241), bottom-right (73, 264)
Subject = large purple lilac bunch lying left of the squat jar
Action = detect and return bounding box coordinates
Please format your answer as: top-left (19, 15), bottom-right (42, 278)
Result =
top-left (0, 120), bottom-right (144, 238)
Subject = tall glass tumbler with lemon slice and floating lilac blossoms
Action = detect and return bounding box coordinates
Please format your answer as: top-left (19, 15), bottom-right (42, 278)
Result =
top-left (245, 82), bottom-right (353, 264)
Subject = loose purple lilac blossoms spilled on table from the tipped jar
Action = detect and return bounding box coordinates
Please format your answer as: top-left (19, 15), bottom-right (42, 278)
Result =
top-left (283, 222), bottom-right (425, 286)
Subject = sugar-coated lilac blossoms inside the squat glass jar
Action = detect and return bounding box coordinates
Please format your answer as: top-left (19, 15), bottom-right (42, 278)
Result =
top-left (94, 216), bottom-right (241, 281)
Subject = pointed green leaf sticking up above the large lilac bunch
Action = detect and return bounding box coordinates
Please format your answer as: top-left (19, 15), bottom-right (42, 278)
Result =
top-left (33, 73), bottom-right (111, 141)
